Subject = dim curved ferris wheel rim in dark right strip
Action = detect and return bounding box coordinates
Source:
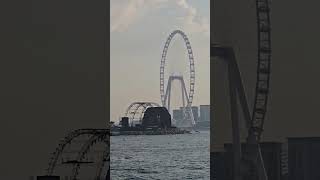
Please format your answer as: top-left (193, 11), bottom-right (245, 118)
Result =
top-left (251, 0), bottom-right (271, 141)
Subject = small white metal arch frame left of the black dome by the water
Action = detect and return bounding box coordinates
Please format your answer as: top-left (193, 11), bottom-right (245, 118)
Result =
top-left (125, 102), bottom-right (160, 122)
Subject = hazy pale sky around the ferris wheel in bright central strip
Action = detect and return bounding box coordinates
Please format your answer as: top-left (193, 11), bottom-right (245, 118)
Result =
top-left (110, 0), bottom-right (210, 121)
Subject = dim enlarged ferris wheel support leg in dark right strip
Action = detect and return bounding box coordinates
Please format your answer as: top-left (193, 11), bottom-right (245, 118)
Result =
top-left (211, 46), bottom-right (268, 180)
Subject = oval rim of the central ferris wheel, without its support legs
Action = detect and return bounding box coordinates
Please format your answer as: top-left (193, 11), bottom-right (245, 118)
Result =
top-left (160, 30), bottom-right (195, 106)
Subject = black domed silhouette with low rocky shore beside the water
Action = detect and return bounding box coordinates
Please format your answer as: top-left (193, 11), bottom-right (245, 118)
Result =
top-left (111, 107), bottom-right (190, 136)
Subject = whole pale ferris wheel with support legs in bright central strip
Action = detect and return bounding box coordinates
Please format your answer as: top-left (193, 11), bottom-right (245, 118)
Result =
top-left (160, 30), bottom-right (195, 126)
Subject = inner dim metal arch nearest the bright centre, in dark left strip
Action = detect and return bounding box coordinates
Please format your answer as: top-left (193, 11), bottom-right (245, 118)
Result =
top-left (72, 131), bottom-right (110, 180)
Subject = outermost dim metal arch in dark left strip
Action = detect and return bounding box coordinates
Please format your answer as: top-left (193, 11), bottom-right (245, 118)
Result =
top-left (46, 129), bottom-right (109, 176)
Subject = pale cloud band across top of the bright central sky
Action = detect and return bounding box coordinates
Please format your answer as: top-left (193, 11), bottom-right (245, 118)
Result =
top-left (111, 0), bottom-right (210, 35)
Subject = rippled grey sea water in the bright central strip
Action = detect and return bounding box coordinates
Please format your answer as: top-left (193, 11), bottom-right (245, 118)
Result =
top-left (110, 131), bottom-right (210, 180)
